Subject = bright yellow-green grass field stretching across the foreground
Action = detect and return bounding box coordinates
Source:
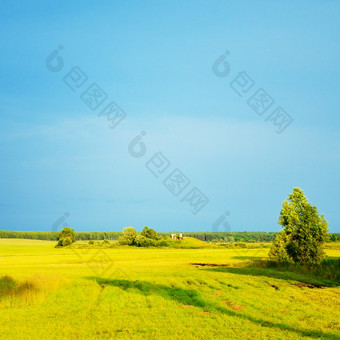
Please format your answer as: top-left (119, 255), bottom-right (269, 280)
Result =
top-left (0, 239), bottom-right (340, 339)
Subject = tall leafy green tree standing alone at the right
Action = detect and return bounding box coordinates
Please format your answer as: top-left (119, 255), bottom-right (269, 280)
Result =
top-left (269, 188), bottom-right (328, 266)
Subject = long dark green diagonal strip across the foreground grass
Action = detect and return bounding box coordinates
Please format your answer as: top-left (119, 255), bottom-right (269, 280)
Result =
top-left (87, 276), bottom-right (340, 340)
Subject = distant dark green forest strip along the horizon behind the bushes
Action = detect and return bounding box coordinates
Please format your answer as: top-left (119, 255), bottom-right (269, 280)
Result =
top-left (0, 230), bottom-right (340, 243)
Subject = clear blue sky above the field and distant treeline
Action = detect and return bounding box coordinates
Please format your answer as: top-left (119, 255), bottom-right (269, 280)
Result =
top-left (0, 1), bottom-right (340, 232)
